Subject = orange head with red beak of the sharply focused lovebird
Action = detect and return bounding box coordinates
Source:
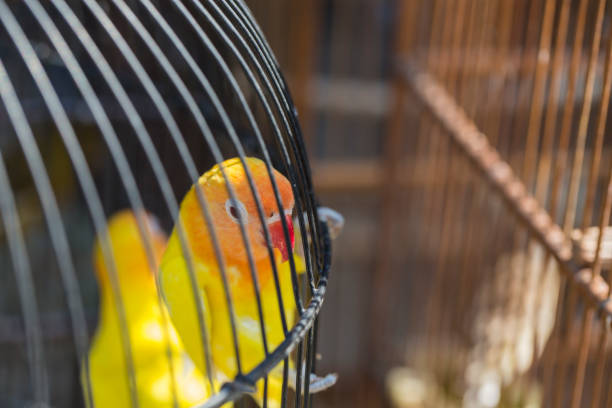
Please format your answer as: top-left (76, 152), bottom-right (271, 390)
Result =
top-left (181, 157), bottom-right (294, 268)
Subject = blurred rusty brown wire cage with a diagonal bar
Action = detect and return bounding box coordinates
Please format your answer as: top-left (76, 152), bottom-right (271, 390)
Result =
top-left (375, 0), bottom-right (612, 407)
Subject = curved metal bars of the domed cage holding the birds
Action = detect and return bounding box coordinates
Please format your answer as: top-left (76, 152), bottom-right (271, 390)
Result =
top-left (0, 0), bottom-right (330, 407)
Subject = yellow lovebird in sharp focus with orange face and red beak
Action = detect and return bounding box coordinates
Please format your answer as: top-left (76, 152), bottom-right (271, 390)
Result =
top-left (159, 158), bottom-right (305, 407)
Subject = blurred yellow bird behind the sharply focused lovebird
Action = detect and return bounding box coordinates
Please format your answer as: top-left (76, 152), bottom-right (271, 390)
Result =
top-left (81, 210), bottom-right (210, 408)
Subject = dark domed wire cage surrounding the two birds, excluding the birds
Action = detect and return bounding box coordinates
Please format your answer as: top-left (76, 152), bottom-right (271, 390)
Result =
top-left (0, 0), bottom-right (330, 407)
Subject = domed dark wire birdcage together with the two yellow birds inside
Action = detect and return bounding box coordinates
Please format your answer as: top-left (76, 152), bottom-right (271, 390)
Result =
top-left (0, 0), bottom-right (341, 407)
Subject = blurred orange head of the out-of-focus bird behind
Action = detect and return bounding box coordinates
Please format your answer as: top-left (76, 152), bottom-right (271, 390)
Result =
top-left (93, 210), bottom-right (166, 289)
